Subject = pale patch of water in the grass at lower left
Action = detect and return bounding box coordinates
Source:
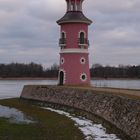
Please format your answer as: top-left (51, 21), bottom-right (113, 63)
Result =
top-left (0, 105), bottom-right (34, 124)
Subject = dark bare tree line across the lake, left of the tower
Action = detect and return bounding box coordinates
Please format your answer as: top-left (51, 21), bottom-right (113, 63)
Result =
top-left (0, 62), bottom-right (58, 78)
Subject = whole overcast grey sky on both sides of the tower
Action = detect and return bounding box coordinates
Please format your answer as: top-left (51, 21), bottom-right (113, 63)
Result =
top-left (0, 0), bottom-right (140, 66)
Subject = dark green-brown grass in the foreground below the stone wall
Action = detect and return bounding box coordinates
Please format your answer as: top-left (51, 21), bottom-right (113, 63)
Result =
top-left (0, 99), bottom-right (84, 140)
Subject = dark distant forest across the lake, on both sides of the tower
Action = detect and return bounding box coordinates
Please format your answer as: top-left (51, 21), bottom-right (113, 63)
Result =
top-left (0, 62), bottom-right (140, 78)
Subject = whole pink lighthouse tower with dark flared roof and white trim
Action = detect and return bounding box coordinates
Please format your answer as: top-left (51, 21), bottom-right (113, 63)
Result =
top-left (57, 0), bottom-right (92, 86)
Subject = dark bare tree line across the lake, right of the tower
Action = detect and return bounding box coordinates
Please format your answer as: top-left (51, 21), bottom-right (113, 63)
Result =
top-left (90, 64), bottom-right (140, 78)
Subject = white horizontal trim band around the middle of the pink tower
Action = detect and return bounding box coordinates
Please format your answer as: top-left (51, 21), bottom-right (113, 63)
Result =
top-left (60, 49), bottom-right (88, 53)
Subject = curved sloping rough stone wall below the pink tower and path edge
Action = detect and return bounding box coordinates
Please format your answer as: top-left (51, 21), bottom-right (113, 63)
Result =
top-left (21, 85), bottom-right (140, 140)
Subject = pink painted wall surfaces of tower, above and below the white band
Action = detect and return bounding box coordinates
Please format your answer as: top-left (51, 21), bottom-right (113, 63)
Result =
top-left (60, 23), bottom-right (90, 86)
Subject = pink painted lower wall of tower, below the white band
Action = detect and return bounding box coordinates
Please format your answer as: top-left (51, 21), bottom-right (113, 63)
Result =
top-left (60, 54), bottom-right (90, 85)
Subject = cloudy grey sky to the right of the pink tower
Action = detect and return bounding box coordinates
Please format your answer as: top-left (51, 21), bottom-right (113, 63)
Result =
top-left (87, 0), bottom-right (140, 65)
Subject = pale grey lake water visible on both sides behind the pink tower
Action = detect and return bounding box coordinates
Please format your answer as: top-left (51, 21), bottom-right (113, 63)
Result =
top-left (0, 80), bottom-right (140, 99)
